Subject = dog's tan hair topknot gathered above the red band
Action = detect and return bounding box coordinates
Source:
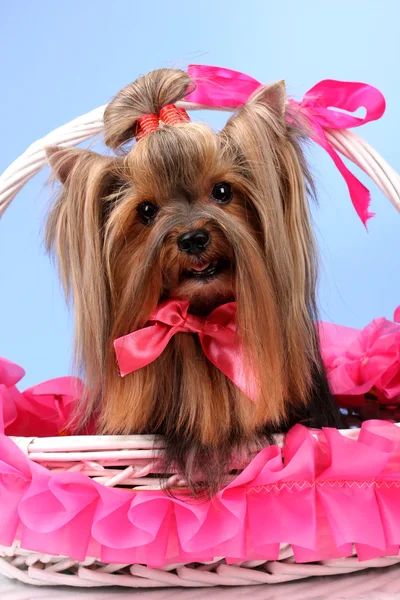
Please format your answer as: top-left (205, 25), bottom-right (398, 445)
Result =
top-left (104, 69), bottom-right (194, 150)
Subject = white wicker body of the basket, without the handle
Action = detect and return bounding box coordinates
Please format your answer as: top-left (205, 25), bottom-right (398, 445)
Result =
top-left (0, 430), bottom-right (400, 588)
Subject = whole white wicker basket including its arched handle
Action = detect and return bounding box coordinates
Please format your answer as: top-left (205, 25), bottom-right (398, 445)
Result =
top-left (0, 67), bottom-right (400, 588)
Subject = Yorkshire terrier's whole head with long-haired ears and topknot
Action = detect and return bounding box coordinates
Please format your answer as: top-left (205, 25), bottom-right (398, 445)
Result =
top-left (48, 69), bottom-right (319, 462)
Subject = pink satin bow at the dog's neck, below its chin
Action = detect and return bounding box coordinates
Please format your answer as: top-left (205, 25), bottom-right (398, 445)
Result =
top-left (114, 300), bottom-right (253, 399)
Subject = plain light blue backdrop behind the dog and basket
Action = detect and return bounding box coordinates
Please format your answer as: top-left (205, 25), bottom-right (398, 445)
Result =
top-left (0, 0), bottom-right (400, 386)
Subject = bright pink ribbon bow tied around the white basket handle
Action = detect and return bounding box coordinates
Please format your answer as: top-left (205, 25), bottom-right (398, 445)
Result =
top-left (186, 65), bottom-right (385, 225)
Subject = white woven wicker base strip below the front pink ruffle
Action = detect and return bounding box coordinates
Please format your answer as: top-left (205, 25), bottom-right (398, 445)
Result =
top-left (0, 546), bottom-right (400, 588)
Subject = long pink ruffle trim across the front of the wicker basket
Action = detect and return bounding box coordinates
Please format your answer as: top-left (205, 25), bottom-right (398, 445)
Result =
top-left (0, 421), bottom-right (400, 567)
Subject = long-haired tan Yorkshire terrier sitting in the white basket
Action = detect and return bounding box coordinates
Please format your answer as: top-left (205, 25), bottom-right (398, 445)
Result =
top-left (47, 69), bottom-right (342, 493)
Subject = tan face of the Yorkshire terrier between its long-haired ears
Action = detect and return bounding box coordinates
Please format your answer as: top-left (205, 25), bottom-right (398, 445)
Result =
top-left (105, 124), bottom-right (263, 318)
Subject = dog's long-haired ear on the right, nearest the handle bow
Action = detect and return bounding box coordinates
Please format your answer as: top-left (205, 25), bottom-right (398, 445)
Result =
top-left (220, 81), bottom-right (319, 420)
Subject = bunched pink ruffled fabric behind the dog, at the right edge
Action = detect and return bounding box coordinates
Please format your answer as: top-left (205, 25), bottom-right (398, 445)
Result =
top-left (320, 309), bottom-right (400, 404)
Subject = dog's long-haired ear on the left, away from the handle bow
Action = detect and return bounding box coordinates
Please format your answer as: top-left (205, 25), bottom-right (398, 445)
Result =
top-left (46, 147), bottom-right (126, 406)
